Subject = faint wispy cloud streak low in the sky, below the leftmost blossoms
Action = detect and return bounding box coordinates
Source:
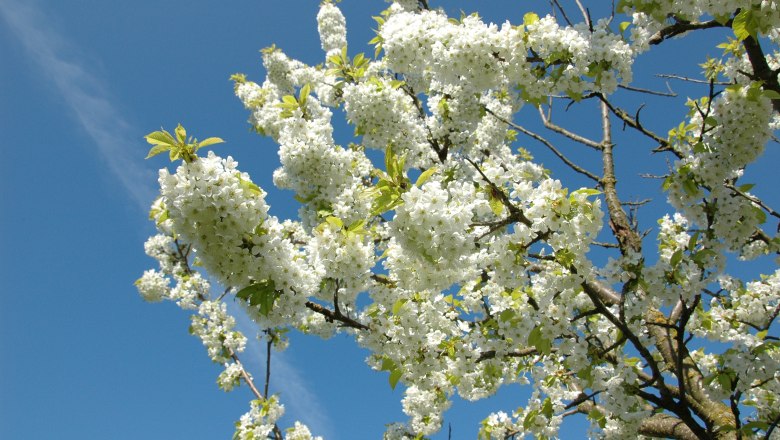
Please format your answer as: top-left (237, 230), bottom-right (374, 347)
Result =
top-left (227, 301), bottom-right (334, 439)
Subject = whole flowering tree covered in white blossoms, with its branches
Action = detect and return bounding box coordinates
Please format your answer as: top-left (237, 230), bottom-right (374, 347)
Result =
top-left (137, 0), bottom-right (780, 439)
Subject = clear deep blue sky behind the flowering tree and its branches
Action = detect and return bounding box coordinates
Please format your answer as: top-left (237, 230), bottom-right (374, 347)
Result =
top-left (0, 0), bottom-right (777, 439)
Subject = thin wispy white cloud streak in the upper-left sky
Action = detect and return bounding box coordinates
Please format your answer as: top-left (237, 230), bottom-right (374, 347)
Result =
top-left (0, 0), bottom-right (155, 210)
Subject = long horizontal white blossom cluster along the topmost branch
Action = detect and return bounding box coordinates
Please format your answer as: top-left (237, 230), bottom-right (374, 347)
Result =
top-left (379, 7), bottom-right (633, 97)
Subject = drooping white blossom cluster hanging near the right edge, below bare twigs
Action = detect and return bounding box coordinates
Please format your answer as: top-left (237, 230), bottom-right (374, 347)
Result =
top-left (665, 86), bottom-right (780, 259)
